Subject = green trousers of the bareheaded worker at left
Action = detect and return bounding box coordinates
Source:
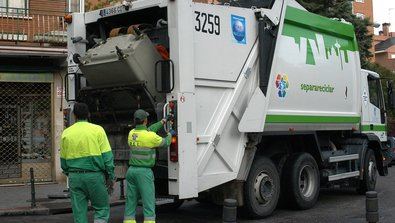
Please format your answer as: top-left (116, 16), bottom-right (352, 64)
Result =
top-left (69, 172), bottom-right (110, 223)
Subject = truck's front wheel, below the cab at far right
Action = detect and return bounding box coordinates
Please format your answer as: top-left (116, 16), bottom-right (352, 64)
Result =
top-left (357, 149), bottom-right (377, 194)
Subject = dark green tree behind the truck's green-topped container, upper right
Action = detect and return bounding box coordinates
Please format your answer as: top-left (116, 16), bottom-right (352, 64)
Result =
top-left (297, 0), bottom-right (373, 68)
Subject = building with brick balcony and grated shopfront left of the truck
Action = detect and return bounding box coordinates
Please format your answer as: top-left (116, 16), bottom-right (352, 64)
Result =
top-left (0, 0), bottom-right (76, 184)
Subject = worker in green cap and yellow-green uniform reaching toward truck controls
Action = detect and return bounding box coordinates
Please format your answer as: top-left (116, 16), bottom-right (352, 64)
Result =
top-left (123, 109), bottom-right (171, 223)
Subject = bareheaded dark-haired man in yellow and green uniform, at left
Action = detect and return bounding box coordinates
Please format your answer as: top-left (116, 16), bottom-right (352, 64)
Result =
top-left (60, 103), bottom-right (115, 223)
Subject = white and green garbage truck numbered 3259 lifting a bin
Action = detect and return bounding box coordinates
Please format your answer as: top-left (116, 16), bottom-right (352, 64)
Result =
top-left (65, 0), bottom-right (393, 218)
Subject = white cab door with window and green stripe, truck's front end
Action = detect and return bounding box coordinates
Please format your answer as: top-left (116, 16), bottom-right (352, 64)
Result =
top-left (362, 74), bottom-right (387, 141)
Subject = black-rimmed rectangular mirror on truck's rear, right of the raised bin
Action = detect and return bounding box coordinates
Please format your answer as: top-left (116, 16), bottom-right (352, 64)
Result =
top-left (155, 60), bottom-right (174, 93)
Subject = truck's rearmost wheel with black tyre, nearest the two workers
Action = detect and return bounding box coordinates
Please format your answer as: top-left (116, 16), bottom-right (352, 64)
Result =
top-left (243, 157), bottom-right (280, 219)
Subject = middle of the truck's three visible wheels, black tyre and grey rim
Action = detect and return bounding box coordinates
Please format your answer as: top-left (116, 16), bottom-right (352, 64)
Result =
top-left (281, 153), bottom-right (320, 210)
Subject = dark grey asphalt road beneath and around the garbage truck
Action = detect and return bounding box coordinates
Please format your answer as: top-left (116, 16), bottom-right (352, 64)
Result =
top-left (0, 167), bottom-right (395, 223)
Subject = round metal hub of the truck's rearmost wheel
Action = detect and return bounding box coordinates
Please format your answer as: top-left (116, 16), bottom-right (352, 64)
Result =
top-left (254, 172), bottom-right (274, 204)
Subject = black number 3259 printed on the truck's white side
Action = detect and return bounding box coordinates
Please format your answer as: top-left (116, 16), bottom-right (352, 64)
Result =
top-left (195, 11), bottom-right (221, 36)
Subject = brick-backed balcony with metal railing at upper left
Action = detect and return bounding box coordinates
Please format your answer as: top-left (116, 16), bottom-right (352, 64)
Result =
top-left (0, 7), bottom-right (67, 48)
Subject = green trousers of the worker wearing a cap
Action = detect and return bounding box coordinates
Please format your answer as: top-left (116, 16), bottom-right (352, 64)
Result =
top-left (124, 166), bottom-right (155, 223)
